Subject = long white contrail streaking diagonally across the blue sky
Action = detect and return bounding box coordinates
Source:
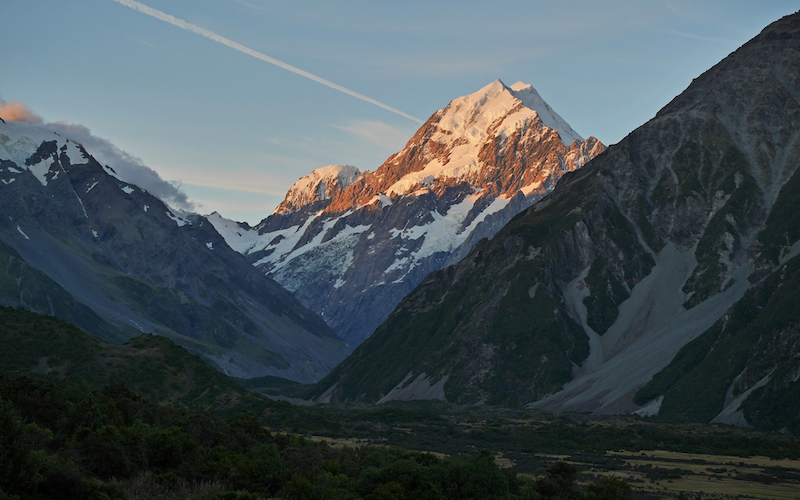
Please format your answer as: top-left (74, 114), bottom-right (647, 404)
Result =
top-left (114, 0), bottom-right (422, 123)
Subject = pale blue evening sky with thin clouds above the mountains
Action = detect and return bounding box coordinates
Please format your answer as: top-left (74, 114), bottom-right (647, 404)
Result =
top-left (0, 0), bottom-right (799, 224)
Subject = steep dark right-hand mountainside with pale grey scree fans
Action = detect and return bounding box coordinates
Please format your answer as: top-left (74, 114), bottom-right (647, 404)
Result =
top-left (312, 10), bottom-right (800, 431)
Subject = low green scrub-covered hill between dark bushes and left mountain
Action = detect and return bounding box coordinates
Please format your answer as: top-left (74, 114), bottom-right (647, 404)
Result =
top-left (0, 307), bottom-right (331, 429)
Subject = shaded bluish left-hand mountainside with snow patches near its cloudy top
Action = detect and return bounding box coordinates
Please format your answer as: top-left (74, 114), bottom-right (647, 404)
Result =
top-left (0, 118), bottom-right (349, 382)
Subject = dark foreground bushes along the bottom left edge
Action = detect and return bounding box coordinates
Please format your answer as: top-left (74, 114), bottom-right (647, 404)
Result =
top-left (0, 377), bottom-right (631, 500)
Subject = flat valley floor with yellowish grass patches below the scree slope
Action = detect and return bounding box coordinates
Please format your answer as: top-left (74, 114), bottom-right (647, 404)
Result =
top-left (280, 402), bottom-right (800, 499)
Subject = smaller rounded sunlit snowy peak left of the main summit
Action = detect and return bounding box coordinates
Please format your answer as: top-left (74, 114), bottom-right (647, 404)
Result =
top-left (273, 165), bottom-right (364, 214)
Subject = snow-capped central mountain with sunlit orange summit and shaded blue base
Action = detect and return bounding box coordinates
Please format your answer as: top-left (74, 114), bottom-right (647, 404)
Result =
top-left (216, 80), bottom-right (604, 345)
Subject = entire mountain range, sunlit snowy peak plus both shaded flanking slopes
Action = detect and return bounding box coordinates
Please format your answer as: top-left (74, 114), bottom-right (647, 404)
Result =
top-left (0, 8), bottom-right (800, 433)
